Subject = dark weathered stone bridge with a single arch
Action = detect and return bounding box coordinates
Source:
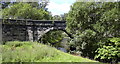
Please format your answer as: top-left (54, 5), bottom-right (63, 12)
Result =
top-left (0, 19), bottom-right (73, 42)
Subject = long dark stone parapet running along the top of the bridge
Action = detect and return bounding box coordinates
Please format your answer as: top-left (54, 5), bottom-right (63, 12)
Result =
top-left (2, 19), bottom-right (66, 27)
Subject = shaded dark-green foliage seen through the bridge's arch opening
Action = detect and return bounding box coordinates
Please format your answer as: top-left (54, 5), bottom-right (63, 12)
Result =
top-left (41, 31), bottom-right (63, 47)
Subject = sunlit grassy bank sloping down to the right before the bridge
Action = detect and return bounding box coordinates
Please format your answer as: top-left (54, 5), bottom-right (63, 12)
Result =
top-left (2, 41), bottom-right (96, 62)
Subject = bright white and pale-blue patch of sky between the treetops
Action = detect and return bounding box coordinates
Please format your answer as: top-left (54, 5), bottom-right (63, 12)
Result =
top-left (47, 0), bottom-right (76, 15)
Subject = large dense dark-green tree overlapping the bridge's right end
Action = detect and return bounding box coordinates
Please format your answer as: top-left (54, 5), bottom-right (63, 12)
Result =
top-left (67, 2), bottom-right (120, 58)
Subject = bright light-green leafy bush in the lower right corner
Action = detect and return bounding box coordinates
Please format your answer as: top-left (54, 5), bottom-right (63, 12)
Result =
top-left (95, 38), bottom-right (120, 61)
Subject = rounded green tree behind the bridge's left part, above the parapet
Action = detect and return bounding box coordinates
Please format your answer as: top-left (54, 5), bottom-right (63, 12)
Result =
top-left (3, 3), bottom-right (51, 20)
